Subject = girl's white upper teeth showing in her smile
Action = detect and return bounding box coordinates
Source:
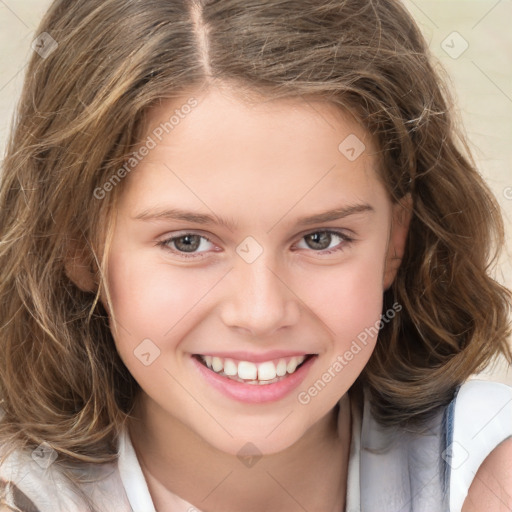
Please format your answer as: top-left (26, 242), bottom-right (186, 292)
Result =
top-left (200, 356), bottom-right (306, 384)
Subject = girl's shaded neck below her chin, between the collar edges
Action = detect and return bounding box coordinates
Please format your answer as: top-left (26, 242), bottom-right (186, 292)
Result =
top-left (129, 394), bottom-right (351, 512)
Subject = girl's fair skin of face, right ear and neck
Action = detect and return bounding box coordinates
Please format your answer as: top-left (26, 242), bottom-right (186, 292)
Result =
top-left (71, 87), bottom-right (410, 512)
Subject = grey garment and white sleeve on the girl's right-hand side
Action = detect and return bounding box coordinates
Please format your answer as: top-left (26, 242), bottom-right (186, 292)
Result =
top-left (354, 379), bottom-right (512, 512)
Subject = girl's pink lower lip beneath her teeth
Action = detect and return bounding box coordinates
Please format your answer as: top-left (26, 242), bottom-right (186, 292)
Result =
top-left (192, 355), bottom-right (317, 403)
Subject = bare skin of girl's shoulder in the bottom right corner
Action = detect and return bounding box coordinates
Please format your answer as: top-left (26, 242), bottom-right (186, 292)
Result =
top-left (462, 436), bottom-right (512, 512)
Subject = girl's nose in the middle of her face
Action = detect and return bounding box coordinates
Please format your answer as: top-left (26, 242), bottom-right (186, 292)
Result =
top-left (221, 253), bottom-right (300, 337)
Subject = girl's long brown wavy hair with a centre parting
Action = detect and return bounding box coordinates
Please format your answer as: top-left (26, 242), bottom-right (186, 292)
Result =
top-left (0, 0), bottom-right (512, 480)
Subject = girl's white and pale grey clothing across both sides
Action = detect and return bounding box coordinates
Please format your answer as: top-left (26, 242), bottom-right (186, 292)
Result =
top-left (0, 380), bottom-right (512, 512)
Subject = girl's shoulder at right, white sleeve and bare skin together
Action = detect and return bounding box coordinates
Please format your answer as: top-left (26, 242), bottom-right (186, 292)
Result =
top-left (446, 380), bottom-right (512, 512)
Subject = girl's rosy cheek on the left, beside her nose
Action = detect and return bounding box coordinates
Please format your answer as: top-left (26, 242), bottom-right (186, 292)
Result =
top-left (105, 251), bottom-right (215, 390)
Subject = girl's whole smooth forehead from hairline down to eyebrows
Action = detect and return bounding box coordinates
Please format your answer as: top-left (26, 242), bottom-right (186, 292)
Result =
top-left (118, 89), bottom-right (386, 218)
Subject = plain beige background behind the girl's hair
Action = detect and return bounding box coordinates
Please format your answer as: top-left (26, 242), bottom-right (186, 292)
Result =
top-left (0, 0), bottom-right (512, 385)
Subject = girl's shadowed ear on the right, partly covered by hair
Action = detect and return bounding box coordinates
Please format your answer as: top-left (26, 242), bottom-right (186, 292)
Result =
top-left (383, 194), bottom-right (413, 290)
